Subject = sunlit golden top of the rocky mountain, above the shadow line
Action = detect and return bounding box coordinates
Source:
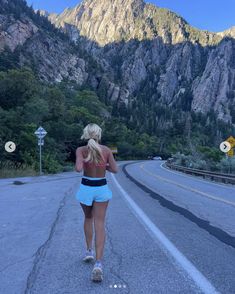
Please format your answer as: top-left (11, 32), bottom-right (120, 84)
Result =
top-left (49, 0), bottom-right (222, 46)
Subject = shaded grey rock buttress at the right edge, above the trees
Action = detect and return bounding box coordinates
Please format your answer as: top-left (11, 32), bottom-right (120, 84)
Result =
top-left (192, 39), bottom-right (235, 121)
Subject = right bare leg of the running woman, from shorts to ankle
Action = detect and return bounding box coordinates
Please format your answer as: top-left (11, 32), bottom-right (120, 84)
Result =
top-left (93, 201), bottom-right (108, 260)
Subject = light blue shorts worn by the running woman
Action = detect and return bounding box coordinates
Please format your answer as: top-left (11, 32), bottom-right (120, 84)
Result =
top-left (76, 176), bottom-right (112, 206)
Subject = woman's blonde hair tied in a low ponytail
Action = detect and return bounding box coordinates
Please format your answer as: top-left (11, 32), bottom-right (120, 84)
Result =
top-left (81, 124), bottom-right (103, 163)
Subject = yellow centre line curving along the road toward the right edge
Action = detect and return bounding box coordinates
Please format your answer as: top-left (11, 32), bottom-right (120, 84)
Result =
top-left (140, 164), bottom-right (235, 207)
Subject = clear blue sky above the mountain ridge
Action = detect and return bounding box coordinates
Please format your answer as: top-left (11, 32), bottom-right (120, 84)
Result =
top-left (27, 0), bottom-right (235, 32)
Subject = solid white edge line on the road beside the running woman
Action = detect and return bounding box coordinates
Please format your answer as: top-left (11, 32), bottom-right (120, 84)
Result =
top-left (111, 174), bottom-right (219, 294)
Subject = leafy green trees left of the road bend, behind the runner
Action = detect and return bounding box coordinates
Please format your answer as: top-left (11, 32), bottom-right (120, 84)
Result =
top-left (0, 69), bottom-right (160, 172)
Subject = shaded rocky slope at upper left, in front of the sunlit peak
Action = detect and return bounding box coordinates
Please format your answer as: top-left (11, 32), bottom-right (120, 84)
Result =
top-left (0, 0), bottom-right (88, 84)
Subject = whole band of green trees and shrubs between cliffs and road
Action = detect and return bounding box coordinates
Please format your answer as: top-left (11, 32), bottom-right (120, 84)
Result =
top-left (0, 67), bottom-right (233, 177)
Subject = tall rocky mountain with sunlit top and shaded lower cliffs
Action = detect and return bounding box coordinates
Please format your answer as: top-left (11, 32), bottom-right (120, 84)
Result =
top-left (42, 0), bottom-right (235, 122)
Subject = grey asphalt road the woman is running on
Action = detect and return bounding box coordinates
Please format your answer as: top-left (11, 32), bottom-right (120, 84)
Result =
top-left (0, 161), bottom-right (235, 294)
